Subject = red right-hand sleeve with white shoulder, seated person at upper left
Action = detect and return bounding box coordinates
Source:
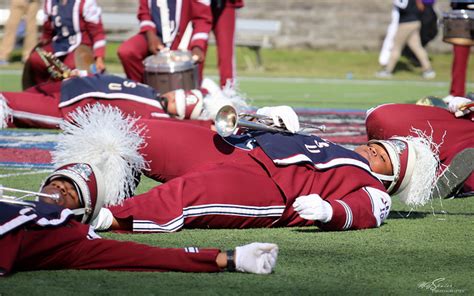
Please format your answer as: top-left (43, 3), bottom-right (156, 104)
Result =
top-left (81, 0), bottom-right (106, 58)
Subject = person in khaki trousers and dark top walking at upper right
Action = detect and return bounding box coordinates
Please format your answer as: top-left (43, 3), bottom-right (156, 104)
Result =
top-left (376, 0), bottom-right (436, 79)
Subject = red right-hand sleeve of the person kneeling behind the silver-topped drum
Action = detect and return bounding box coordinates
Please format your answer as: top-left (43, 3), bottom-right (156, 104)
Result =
top-left (189, 0), bottom-right (212, 50)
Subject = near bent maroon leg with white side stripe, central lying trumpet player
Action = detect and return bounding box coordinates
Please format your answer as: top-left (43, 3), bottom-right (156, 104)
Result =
top-left (110, 156), bottom-right (285, 232)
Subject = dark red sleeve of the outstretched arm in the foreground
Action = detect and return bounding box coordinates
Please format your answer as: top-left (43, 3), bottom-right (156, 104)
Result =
top-left (9, 221), bottom-right (220, 272)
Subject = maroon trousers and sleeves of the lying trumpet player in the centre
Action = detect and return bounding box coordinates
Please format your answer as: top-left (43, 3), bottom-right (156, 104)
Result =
top-left (110, 120), bottom-right (391, 232)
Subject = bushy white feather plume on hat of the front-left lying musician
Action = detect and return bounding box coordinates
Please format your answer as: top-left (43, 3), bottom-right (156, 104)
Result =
top-left (52, 104), bottom-right (147, 206)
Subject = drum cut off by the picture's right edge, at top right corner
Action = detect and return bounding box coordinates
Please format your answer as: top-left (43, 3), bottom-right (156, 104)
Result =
top-left (443, 9), bottom-right (474, 45)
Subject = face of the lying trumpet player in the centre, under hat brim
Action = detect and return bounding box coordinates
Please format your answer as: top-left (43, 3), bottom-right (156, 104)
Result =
top-left (354, 143), bottom-right (393, 175)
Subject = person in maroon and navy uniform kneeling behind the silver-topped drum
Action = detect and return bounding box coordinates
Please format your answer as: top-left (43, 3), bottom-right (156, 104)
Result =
top-left (117, 0), bottom-right (212, 82)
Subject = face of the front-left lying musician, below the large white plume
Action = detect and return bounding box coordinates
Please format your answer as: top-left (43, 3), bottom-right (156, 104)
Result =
top-left (40, 178), bottom-right (80, 209)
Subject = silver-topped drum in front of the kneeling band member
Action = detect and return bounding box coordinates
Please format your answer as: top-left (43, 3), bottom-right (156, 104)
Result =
top-left (143, 50), bottom-right (200, 94)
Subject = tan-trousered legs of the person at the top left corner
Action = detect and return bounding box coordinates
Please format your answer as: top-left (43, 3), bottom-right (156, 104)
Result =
top-left (0, 0), bottom-right (40, 66)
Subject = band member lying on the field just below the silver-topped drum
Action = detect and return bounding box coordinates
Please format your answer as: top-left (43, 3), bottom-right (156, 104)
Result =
top-left (0, 74), bottom-right (247, 128)
